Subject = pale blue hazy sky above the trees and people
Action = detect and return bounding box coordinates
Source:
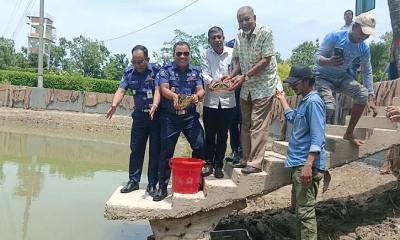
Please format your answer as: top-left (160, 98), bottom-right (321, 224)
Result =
top-left (0, 0), bottom-right (391, 59)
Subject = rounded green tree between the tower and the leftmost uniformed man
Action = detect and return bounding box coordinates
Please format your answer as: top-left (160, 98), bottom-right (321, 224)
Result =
top-left (68, 36), bottom-right (110, 78)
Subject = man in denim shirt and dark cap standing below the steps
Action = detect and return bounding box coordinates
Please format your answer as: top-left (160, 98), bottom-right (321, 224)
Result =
top-left (276, 64), bottom-right (327, 240)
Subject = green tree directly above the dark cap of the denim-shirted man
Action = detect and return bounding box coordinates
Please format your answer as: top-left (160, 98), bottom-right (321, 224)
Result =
top-left (289, 41), bottom-right (319, 66)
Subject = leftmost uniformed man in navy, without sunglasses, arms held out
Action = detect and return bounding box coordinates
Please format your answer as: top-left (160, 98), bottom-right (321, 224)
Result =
top-left (106, 45), bottom-right (161, 196)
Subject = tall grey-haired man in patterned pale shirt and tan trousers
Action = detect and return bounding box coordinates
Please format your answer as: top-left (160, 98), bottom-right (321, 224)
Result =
top-left (230, 6), bottom-right (282, 174)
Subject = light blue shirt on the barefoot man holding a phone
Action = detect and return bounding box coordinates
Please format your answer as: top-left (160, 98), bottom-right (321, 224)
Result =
top-left (314, 31), bottom-right (374, 94)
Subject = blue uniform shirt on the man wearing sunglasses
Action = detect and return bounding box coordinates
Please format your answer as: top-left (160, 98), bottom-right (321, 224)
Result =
top-left (157, 62), bottom-right (203, 112)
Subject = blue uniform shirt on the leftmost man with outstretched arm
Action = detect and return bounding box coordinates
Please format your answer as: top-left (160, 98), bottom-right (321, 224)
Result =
top-left (119, 63), bottom-right (161, 110)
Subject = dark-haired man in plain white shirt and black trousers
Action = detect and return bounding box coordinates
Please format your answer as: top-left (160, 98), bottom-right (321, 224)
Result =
top-left (201, 27), bottom-right (236, 178)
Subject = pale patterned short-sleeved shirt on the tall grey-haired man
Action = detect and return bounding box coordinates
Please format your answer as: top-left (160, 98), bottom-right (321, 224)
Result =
top-left (233, 24), bottom-right (283, 100)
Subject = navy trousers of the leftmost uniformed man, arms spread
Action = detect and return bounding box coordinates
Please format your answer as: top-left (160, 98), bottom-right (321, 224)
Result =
top-left (129, 110), bottom-right (161, 185)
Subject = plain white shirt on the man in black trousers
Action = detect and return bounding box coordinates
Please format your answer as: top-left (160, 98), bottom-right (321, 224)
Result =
top-left (201, 47), bottom-right (236, 108)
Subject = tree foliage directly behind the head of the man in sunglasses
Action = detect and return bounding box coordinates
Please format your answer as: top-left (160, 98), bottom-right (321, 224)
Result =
top-left (153, 29), bottom-right (208, 66)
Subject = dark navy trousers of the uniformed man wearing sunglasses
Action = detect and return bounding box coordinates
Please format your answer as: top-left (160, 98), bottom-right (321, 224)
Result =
top-left (158, 112), bottom-right (204, 190)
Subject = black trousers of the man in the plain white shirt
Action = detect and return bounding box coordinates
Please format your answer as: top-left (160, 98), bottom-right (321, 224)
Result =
top-left (203, 106), bottom-right (235, 168)
